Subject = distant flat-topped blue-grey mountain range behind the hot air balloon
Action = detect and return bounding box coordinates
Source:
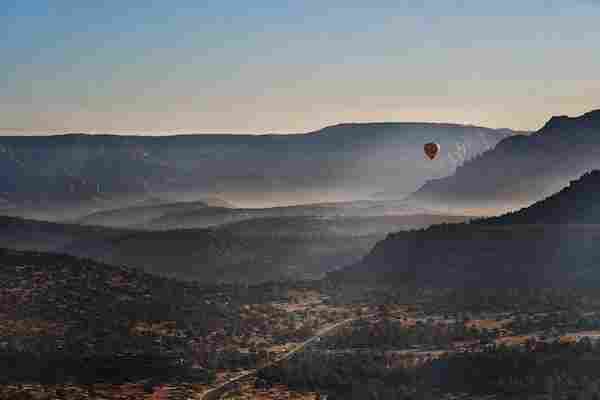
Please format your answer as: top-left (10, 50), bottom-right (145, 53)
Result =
top-left (0, 123), bottom-right (514, 217)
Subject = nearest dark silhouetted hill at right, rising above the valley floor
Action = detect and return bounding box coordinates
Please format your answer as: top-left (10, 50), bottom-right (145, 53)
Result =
top-left (330, 171), bottom-right (600, 288)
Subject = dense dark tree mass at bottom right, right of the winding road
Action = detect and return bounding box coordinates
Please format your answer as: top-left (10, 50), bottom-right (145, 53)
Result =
top-left (260, 341), bottom-right (600, 400)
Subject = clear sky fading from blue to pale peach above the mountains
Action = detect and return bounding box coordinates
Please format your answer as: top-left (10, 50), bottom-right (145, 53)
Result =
top-left (0, 0), bottom-right (600, 133)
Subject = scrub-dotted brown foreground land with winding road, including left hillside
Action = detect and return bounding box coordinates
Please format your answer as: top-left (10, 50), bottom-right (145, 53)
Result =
top-left (0, 250), bottom-right (600, 400)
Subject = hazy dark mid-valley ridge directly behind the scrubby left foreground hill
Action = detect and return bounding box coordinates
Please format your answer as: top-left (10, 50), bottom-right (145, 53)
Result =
top-left (0, 215), bottom-right (464, 283)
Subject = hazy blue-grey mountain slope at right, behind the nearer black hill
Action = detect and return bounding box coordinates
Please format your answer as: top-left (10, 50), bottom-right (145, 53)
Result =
top-left (410, 110), bottom-right (600, 208)
